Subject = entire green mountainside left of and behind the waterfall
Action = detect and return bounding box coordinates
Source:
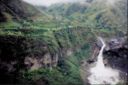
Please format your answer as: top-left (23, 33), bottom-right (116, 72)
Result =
top-left (0, 0), bottom-right (127, 85)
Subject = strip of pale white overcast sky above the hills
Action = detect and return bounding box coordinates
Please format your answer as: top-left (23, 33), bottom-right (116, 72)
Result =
top-left (23, 0), bottom-right (81, 6)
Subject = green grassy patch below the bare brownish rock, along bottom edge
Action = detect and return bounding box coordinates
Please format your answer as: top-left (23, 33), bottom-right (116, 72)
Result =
top-left (23, 68), bottom-right (82, 85)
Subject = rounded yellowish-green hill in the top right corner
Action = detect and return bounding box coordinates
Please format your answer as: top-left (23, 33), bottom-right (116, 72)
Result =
top-left (85, 0), bottom-right (127, 31)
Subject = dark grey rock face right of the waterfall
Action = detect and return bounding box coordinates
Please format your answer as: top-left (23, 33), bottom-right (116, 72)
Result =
top-left (104, 39), bottom-right (128, 83)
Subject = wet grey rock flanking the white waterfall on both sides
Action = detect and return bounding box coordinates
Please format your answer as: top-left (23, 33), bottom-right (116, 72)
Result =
top-left (84, 38), bottom-right (128, 84)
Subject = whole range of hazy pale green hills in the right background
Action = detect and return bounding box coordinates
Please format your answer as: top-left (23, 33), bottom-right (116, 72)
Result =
top-left (37, 0), bottom-right (127, 32)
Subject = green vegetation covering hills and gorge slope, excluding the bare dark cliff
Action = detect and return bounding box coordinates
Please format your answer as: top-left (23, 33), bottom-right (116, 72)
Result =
top-left (0, 0), bottom-right (126, 85)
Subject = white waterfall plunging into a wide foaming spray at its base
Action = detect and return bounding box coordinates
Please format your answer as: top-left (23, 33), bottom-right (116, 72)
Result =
top-left (88, 37), bottom-right (119, 85)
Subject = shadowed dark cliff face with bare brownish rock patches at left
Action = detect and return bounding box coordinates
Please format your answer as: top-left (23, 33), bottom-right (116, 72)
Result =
top-left (0, 36), bottom-right (58, 84)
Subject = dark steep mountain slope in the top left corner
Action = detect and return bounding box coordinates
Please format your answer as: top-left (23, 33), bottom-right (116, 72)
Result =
top-left (0, 0), bottom-right (39, 22)
